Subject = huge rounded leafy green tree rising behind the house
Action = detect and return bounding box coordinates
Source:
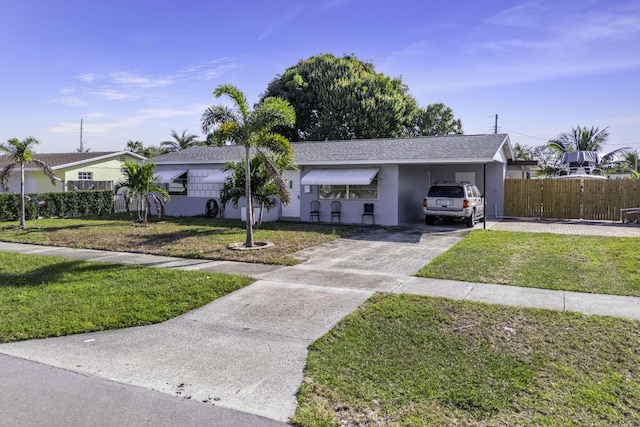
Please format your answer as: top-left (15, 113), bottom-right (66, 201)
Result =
top-left (263, 54), bottom-right (418, 141)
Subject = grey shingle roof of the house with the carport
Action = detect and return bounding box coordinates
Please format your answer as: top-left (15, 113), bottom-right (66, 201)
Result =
top-left (150, 134), bottom-right (513, 165)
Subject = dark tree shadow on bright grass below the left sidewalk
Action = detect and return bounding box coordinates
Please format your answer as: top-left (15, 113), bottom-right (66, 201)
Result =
top-left (0, 260), bottom-right (124, 287)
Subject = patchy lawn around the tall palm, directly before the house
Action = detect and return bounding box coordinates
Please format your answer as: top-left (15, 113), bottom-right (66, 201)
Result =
top-left (0, 214), bottom-right (359, 265)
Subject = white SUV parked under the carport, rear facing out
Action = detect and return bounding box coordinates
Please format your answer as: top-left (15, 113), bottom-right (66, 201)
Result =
top-left (422, 181), bottom-right (484, 227)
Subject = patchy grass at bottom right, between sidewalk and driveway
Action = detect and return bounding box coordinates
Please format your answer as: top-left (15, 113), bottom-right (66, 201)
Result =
top-left (293, 294), bottom-right (640, 426)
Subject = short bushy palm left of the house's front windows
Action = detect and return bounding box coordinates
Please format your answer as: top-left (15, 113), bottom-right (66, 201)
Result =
top-left (116, 162), bottom-right (169, 223)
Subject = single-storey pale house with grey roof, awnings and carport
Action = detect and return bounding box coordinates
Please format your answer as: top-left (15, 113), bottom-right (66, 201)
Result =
top-left (151, 134), bottom-right (513, 225)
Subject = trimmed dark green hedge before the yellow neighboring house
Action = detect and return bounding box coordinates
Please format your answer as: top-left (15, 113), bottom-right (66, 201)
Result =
top-left (0, 191), bottom-right (114, 222)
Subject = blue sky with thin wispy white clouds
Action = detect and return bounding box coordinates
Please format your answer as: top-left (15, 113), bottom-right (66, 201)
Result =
top-left (0, 0), bottom-right (640, 153)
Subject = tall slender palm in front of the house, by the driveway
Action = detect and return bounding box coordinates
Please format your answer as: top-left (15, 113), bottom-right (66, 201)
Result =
top-left (202, 85), bottom-right (296, 248)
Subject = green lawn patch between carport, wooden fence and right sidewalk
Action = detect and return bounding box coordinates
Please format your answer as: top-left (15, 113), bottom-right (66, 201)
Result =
top-left (418, 231), bottom-right (640, 296)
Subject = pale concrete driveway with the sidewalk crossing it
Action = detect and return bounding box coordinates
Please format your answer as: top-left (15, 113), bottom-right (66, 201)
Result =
top-left (0, 227), bottom-right (640, 425)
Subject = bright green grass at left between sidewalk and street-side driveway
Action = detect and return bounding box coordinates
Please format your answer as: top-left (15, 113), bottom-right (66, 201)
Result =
top-left (0, 252), bottom-right (253, 342)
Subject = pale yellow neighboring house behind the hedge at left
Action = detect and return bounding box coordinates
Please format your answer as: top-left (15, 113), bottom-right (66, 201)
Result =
top-left (0, 151), bottom-right (145, 193)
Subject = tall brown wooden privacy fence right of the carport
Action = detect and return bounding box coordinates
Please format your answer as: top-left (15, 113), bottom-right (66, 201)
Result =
top-left (504, 179), bottom-right (640, 221)
